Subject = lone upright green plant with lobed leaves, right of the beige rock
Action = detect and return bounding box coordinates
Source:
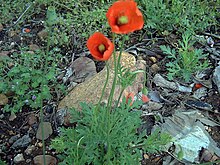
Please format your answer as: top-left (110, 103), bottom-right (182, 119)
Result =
top-left (160, 31), bottom-right (209, 82)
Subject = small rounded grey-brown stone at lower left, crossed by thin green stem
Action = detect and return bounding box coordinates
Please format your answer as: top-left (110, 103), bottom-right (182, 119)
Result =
top-left (36, 122), bottom-right (53, 140)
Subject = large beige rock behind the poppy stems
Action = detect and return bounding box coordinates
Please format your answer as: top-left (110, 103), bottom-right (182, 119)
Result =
top-left (58, 52), bottom-right (145, 110)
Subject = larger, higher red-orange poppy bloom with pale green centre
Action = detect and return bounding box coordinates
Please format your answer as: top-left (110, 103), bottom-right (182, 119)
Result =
top-left (106, 0), bottom-right (144, 34)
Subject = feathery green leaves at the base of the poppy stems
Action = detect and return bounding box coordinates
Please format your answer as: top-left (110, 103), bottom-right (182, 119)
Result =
top-left (51, 98), bottom-right (171, 165)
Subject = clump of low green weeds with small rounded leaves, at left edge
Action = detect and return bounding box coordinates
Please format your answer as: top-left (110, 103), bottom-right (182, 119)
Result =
top-left (0, 48), bottom-right (63, 113)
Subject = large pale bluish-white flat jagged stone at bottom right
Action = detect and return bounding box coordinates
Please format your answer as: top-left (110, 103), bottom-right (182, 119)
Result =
top-left (153, 109), bottom-right (220, 164)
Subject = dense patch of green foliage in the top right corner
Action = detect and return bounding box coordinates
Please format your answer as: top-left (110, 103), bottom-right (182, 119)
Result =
top-left (137, 0), bottom-right (218, 33)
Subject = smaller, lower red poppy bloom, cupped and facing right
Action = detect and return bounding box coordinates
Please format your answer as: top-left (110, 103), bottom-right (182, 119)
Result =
top-left (87, 32), bottom-right (114, 61)
